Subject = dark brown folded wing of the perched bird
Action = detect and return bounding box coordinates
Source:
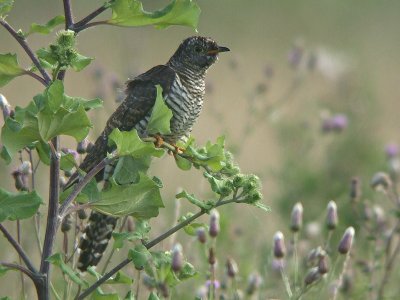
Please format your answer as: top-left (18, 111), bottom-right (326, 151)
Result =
top-left (67, 65), bottom-right (176, 186)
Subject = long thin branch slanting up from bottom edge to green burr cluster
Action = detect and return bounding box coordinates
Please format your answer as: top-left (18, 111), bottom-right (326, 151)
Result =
top-left (76, 197), bottom-right (246, 300)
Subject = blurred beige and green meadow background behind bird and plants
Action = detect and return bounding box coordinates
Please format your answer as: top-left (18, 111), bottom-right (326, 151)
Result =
top-left (0, 0), bottom-right (400, 299)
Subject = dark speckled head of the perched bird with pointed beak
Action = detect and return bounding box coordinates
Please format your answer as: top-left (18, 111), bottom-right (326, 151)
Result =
top-left (170, 36), bottom-right (229, 71)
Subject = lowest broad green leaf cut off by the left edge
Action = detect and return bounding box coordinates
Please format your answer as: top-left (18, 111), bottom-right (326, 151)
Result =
top-left (0, 188), bottom-right (43, 222)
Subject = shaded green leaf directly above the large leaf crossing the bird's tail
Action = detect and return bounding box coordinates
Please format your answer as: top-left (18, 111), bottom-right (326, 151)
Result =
top-left (113, 156), bottom-right (151, 184)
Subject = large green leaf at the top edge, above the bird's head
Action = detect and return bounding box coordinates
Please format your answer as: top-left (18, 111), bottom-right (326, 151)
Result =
top-left (107, 0), bottom-right (200, 29)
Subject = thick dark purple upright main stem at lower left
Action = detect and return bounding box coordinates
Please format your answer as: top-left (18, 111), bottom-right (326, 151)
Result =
top-left (40, 136), bottom-right (60, 299)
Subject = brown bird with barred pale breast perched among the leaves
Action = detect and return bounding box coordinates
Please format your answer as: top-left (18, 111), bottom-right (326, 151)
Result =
top-left (72, 36), bottom-right (230, 272)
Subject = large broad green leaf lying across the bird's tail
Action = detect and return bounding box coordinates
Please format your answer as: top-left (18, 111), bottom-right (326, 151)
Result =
top-left (91, 174), bottom-right (164, 219)
